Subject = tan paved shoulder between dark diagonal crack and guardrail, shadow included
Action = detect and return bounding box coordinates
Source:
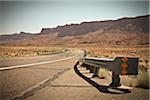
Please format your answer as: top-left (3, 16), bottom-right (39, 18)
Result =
top-left (25, 63), bottom-right (149, 100)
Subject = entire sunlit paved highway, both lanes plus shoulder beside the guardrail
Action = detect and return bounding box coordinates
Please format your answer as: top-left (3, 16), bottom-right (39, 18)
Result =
top-left (0, 49), bottom-right (149, 100)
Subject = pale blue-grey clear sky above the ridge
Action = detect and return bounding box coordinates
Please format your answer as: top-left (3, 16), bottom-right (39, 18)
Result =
top-left (0, 0), bottom-right (149, 34)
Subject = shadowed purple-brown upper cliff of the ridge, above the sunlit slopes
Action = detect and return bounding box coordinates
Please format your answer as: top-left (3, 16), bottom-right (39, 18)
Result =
top-left (41, 16), bottom-right (149, 37)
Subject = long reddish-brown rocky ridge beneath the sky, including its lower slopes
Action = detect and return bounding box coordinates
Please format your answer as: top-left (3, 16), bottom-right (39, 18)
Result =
top-left (0, 15), bottom-right (149, 46)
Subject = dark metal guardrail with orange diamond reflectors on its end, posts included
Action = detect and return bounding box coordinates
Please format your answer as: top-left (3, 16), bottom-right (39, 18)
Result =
top-left (81, 57), bottom-right (139, 87)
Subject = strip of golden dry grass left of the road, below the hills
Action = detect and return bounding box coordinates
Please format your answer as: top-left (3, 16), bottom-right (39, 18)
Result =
top-left (0, 46), bottom-right (64, 57)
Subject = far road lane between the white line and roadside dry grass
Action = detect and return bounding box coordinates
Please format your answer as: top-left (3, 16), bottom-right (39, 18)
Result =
top-left (0, 50), bottom-right (79, 67)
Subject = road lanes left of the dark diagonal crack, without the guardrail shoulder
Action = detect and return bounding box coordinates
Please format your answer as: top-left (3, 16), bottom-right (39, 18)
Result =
top-left (0, 49), bottom-right (83, 100)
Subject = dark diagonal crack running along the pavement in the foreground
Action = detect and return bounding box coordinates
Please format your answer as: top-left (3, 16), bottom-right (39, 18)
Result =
top-left (11, 68), bottom-right (71, 100)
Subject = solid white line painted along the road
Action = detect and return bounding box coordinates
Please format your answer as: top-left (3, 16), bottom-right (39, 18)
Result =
top-left (0, 56), bottom-right (74, 71)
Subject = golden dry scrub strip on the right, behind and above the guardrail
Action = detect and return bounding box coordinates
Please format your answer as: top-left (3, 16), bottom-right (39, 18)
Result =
top-left (86, 47), bottom-right (149, 58)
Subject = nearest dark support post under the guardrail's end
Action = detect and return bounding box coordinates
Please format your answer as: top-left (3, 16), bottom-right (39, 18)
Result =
top-left (109, 72), bottom-right (121, 87)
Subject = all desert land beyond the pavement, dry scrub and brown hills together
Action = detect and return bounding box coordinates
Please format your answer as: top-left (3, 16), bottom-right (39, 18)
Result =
top-left (0, 10), bottom-right (150, 99)
